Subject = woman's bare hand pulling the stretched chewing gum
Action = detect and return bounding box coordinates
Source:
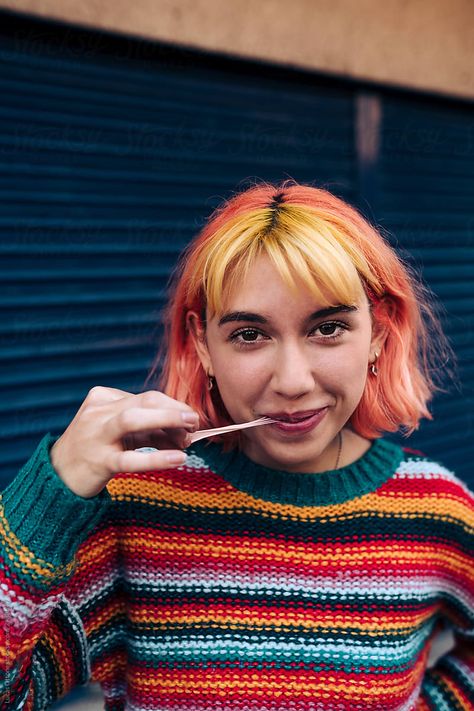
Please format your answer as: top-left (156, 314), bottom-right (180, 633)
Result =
top-left (50, 385), bottom-right (199, 498)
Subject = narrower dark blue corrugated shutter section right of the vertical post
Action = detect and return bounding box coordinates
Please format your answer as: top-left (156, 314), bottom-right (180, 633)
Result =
top-left (376, 95), bottom-right (474, 484)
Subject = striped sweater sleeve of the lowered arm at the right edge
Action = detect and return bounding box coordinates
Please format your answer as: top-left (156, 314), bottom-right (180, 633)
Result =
top-left (416, 482), bottom-right (474, 711)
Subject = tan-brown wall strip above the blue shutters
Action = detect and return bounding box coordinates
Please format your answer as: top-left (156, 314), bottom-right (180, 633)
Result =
top-left (0, 0), bottom-right (474, 98)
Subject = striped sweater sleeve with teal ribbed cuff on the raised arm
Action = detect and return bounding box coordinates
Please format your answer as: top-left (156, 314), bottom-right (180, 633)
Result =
top-left (0, 433), bottom-right (110, 710)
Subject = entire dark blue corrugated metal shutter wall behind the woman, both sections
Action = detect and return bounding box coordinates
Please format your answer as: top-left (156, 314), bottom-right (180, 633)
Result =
top-left (0, 13), bottom-right (474, 486)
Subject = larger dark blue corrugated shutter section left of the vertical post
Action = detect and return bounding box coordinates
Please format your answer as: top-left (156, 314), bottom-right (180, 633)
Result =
top-left (0, 14), bottom-right (356, 485)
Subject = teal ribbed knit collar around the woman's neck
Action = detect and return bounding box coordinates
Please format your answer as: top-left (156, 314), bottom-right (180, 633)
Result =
top-left (189, 438), bottom-right (404, 506)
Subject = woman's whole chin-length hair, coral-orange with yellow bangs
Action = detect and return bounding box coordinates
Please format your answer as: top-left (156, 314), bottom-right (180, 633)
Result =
top-left (146, 179), bottom-right (455, 446)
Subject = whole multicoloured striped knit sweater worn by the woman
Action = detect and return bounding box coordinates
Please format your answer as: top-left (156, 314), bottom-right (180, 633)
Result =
top-left (0, 434), bottom-right (474, 711)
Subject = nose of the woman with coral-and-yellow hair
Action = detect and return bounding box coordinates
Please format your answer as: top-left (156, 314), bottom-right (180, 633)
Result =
top-left (272, 344), bottom-right (314, 399)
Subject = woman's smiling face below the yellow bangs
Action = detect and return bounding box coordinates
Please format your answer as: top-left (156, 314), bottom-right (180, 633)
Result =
top-left (193, 256), bottom-right (382, 472)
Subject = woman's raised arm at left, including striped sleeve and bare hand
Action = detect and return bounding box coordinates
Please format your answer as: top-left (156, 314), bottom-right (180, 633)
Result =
top-left (0, 386), bottom-right (198, 709)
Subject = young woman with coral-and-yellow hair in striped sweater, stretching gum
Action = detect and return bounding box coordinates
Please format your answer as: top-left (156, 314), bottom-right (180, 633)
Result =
top-left (0, 181), bottom-right (474, 711)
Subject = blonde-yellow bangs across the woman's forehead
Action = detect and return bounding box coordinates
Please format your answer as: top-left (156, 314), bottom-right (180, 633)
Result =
top-left (195, 205), bottom-right (377, 317)
